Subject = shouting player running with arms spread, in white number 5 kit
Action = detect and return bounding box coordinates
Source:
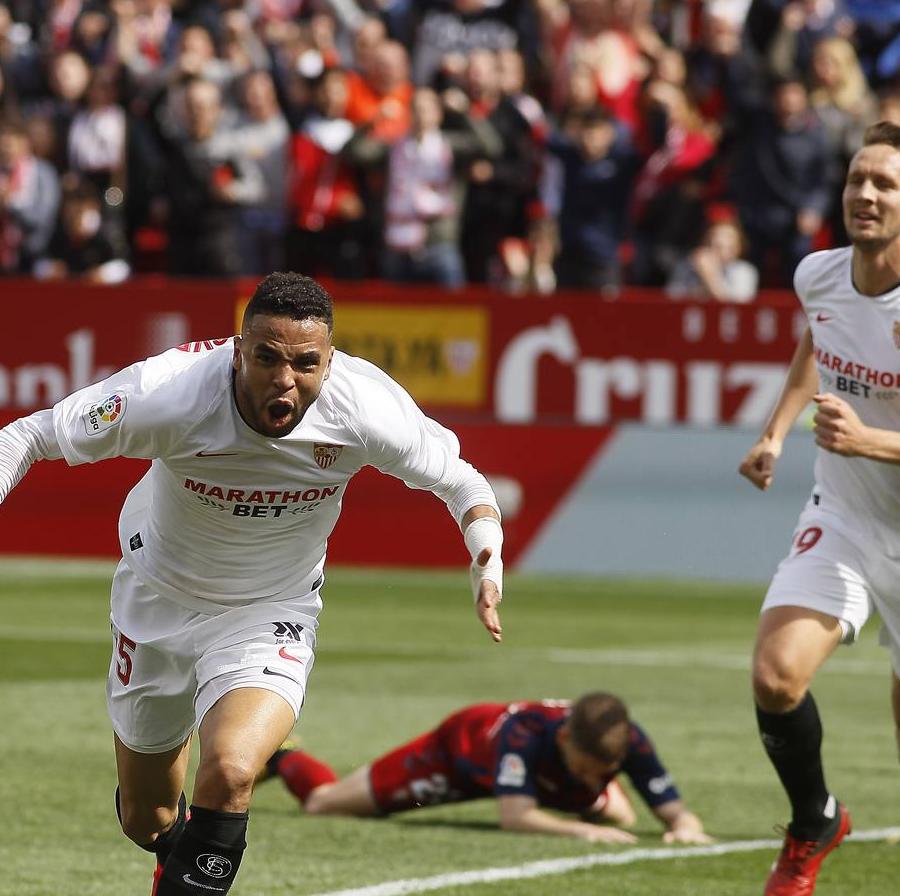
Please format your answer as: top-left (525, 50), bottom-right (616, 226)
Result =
top-left (0, 274), bottom-right (502, 896)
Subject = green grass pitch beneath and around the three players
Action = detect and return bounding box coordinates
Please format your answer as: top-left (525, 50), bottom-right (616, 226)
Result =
top-left (0, 560), bottom-right (900, 896)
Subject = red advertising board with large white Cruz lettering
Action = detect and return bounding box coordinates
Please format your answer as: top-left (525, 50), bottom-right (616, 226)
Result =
top-left (488, 301), bottom-right (804, 426)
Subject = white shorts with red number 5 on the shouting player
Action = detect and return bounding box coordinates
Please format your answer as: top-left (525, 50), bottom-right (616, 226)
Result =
top-left (106, 561), bottom-right (322, 753)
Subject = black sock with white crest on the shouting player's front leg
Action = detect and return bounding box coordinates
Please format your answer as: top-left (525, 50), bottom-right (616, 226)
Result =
top-left (156, 806), bottom-right (248, 896)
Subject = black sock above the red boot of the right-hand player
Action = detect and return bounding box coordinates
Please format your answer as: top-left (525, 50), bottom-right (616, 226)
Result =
top-left (756, 692), bottom-right (829, 840)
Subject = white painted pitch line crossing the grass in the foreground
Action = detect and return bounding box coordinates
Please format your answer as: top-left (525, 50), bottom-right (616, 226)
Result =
top-left (316, 828), bottom-right (900, 896)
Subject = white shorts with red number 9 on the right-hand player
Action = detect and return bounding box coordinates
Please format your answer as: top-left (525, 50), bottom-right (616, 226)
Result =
top-left (762, 497), bottom-right (900, 675)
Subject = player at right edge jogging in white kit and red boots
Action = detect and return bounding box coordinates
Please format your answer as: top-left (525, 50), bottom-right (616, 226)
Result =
top-left (740, 122), bottom-right (900, 896)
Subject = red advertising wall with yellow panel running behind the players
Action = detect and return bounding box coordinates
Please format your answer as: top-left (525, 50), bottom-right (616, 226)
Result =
top-left (0, 280), bottom-right (803, 566)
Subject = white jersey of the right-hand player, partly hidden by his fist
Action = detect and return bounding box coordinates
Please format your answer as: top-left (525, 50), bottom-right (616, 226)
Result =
top-left (794, 247), bottom-right (900, 541)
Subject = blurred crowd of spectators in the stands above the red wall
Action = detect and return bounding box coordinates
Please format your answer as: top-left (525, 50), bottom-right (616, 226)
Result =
top-left (0, 0), bottom-right (900, 301)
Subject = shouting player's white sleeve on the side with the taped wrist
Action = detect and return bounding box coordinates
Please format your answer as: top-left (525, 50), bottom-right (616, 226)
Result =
top-left (366, 376), bottom-right (500, 524)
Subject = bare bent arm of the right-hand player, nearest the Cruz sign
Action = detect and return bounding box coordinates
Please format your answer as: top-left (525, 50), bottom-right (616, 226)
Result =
top-left (738, 327), bottom-right (819, 491)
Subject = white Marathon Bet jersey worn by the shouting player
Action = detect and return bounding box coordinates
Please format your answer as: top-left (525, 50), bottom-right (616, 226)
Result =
top-left (53, 338), bottom-right (496, 612)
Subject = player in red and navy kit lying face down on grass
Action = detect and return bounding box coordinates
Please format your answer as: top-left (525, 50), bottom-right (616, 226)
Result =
top-left (260, 692), bottom-right (711, 843)
